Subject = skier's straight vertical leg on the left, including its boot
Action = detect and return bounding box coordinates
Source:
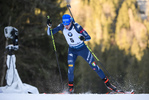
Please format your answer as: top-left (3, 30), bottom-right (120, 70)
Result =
top-left (68, 49), bottom-right (77, 93)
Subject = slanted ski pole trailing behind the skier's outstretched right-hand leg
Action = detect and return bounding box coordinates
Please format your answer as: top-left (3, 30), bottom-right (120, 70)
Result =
top-left (85, 44), bottom-right (121, 88)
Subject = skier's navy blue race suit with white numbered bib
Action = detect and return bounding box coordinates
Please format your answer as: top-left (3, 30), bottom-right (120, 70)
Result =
top-left (47, 23), bottom-right (105, 82)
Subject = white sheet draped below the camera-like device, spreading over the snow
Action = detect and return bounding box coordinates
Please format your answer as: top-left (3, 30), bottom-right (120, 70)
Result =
top-left (0, 50), bottom-right (39, 94)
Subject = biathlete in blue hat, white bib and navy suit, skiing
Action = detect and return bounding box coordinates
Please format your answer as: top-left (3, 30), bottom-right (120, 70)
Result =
top-left (47, 14), bottom-right (118, 93)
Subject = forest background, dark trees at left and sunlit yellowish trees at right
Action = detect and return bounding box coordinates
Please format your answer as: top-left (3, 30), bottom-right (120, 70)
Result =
top-left (0, 0), bottom-right (149, 93)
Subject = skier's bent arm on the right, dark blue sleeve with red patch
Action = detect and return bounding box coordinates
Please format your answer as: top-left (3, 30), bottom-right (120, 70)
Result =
top-left (74, 23), bottom-right (91, 41)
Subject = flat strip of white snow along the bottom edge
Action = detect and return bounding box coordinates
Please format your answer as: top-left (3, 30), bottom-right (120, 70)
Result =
top-left (0, 93), bottom-right (149, 100)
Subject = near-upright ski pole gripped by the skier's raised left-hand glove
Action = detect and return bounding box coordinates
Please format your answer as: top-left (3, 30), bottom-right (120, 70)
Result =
top-left (50, 23), bottom-right (64, 90)
